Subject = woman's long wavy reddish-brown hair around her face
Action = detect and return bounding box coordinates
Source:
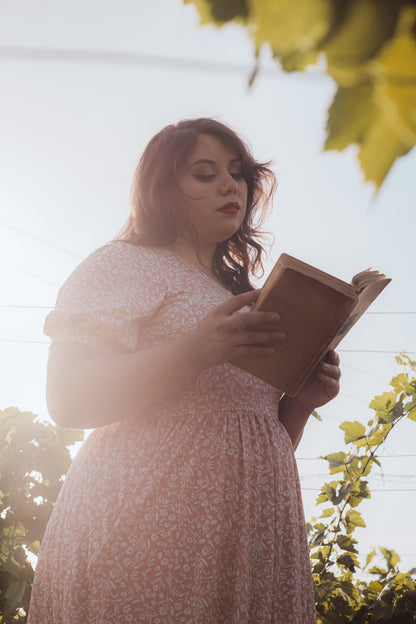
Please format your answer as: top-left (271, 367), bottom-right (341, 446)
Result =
top-left (115, 118), bottom-right (276, 294)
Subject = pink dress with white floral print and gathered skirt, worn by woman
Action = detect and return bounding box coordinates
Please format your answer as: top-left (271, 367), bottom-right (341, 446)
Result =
top-left (28, 242), bottom-right (316, 624)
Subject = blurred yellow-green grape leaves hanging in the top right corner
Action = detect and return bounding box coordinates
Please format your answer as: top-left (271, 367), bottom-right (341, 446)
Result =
top-left (183, 0), bottom-right (416, 188)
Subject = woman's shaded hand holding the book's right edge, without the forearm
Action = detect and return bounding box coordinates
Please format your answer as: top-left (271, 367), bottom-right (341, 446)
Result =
top-left (294, 351), bottom-right (341, 413)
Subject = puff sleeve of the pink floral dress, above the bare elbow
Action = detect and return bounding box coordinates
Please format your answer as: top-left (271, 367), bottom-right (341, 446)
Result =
top-left (44, 242), bottom-right (167, 353)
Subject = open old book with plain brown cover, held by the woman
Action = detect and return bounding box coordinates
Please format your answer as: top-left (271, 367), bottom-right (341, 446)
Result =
top-left (232, 254), bottom-right (391, 396)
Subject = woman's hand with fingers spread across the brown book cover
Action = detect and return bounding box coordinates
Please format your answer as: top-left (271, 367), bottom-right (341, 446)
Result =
top-left (189, 290), bottom-right (286, 368)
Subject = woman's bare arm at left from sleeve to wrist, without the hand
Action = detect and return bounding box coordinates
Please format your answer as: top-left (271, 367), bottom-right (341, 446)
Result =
top-left (46, 338), bottom-right (203, 429)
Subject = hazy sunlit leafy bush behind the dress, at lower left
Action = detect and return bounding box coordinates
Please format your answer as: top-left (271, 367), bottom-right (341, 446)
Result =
top-left (0, 407), bottom-right (84, 624)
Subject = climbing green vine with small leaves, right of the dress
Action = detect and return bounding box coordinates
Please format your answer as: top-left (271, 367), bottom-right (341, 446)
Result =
top-left (307, 355), bottom-right (416, 624)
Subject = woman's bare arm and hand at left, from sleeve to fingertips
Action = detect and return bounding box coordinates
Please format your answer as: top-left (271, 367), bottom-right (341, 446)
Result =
top-left (46, 291), bottom-right (284, 429)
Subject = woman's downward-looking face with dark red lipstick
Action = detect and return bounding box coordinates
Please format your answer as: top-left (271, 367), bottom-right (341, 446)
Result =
top-left (178, 134), bottom-right (247, 248)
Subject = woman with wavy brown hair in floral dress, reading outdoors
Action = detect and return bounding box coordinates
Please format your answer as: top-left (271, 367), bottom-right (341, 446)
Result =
top-left (29, 119), bottom-right (340, 624)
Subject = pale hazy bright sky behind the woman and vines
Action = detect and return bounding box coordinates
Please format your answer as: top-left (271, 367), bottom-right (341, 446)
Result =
top-left (0, 0), bottom-right (416, 570)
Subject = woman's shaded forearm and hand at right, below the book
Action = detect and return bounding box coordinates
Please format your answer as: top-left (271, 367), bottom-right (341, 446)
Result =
top-left (279, 351), bottom-right (341, 450)
